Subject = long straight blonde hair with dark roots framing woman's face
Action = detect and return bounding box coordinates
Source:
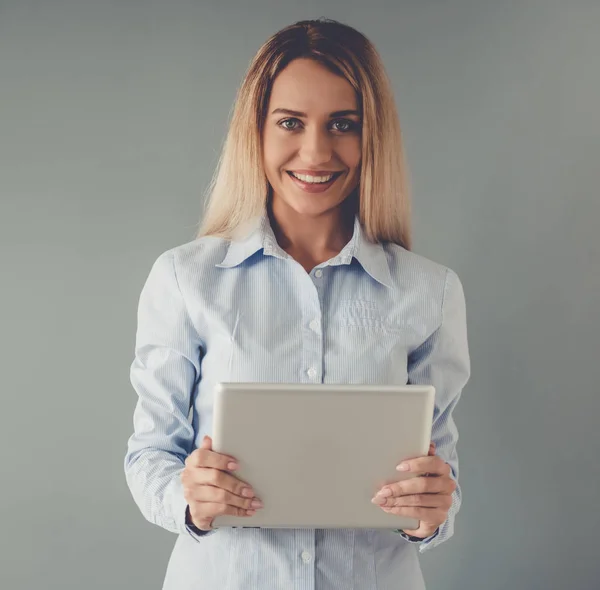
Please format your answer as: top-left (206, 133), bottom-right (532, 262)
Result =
top-left (197, 19), bottom-right (411, 249)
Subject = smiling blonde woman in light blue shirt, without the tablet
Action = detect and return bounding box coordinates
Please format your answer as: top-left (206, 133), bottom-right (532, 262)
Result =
top-left (125, 20), bottom-right (470, 590)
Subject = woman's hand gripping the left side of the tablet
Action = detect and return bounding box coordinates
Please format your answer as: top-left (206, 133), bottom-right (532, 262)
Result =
top-left (181, 436), bottom-right (262, 531)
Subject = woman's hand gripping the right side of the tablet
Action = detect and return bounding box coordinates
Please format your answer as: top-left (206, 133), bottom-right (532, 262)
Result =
top-left (372, 442), bottom-right (457, 539)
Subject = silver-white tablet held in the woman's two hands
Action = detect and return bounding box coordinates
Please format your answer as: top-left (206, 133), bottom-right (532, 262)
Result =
top-left (212, 383), bottom-right (435, 529)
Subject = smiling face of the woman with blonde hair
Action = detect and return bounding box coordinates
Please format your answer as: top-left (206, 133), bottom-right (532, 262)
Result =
top-left (262, 59), bottom-right (361, 216)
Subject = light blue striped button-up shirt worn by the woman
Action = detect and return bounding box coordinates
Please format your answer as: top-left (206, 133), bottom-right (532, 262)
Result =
top-left (124, 215), bottom-right (470, 590)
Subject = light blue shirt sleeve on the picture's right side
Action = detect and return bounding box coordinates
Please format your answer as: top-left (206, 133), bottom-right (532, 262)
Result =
top-left (396, 269), bottom-right (471, 553)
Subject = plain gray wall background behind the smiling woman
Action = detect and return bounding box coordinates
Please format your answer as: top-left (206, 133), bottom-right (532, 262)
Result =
top-left (0, 0), bottom-right (600, 590)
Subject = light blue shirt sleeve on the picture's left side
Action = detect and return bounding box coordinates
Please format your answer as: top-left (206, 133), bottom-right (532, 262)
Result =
top-left (124, 250), bottom-right (212, 540)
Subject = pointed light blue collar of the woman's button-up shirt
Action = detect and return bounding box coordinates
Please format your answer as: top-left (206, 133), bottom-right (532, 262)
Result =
top-left (216, 213), bottom-right (392, 287)
